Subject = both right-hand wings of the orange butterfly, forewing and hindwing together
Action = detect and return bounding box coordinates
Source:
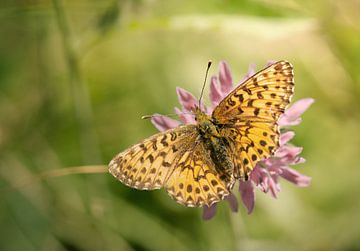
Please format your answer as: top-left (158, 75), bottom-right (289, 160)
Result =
top-left (212, 61), bottom-right (294, 177)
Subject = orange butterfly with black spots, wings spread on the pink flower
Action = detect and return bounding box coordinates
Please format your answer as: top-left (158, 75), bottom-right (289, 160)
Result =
top-left (109, 61), bottom-right (294, 207)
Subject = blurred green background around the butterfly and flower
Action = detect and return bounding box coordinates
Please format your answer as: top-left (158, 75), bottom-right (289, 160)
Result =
top-left (0, 0), bottom-right (360, 251)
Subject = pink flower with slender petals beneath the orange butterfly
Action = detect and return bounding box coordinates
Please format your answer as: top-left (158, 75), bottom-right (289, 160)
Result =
top-left (151, 61), bottom-right (314, 220)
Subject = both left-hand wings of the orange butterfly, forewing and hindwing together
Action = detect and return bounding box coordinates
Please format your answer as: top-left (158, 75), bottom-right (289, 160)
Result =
top-left (109, 125), bottom-right (229, 207)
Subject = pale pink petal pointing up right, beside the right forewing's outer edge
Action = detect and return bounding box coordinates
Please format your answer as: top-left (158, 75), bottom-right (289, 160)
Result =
top-left (279, 98), bottom-right (315, 126)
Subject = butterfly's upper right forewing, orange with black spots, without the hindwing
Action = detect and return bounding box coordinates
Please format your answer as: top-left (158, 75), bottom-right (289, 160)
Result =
top-left (212, 61), bottom-right (294, 124)
